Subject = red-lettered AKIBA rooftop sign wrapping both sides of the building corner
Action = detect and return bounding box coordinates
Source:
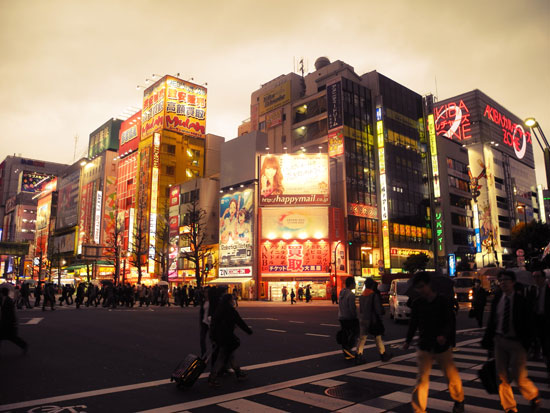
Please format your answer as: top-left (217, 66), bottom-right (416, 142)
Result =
top-left (434, 90), bottom-right (534, 168)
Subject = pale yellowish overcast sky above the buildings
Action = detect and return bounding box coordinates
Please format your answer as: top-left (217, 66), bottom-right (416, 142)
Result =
top-left (0, 0), bottom-right (550, 186)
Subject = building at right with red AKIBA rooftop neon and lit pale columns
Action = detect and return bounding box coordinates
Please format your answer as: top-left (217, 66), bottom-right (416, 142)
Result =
top-left (434, 90), bottom-right (539, 268)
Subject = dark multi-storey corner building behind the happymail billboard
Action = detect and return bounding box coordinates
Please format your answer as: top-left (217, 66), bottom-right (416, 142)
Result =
top-left (250, 58), bottom-right (437, 287)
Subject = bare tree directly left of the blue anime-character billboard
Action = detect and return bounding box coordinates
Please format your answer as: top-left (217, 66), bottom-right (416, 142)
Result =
top-left (181, 190), bottom-right (212, 287)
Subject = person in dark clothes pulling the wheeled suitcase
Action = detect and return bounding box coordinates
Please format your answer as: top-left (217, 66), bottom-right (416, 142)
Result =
top-left (208, 294), bottom-right (252, 387)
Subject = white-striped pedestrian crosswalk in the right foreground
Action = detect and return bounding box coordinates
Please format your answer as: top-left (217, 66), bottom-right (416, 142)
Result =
top-left (170, 339), bottom-right (550, 413)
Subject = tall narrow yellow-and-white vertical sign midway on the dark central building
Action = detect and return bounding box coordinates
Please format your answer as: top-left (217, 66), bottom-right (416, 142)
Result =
top-left (376, 106), bottom-right (391, 268)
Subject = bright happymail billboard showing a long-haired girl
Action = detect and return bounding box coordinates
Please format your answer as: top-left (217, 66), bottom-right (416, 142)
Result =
top-left (260, 153), bottom-right (330, 206)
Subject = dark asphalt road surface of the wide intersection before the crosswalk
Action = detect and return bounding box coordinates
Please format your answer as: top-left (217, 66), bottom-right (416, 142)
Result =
top-left (0, 302), bottom-right (516, 412)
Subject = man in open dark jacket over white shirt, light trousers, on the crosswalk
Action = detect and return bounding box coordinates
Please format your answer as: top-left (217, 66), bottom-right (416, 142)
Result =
top-left (481, 271), bottom-right (541, 413)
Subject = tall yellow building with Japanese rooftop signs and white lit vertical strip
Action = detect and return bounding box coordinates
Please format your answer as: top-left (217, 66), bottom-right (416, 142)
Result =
top-left (134, 75), bottom-right (206, 277)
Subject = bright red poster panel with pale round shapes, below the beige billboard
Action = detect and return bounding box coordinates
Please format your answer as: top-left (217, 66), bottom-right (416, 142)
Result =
top-left (261, 240), bottom-right (330, 275)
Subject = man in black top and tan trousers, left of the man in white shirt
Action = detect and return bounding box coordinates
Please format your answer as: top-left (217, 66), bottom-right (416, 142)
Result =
top-left (403, 271), bottom-right (464, 413)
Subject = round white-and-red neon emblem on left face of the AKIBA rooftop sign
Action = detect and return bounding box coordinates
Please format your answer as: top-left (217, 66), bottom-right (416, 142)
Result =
top-left (434, 100), bottom-right (472, 141)
